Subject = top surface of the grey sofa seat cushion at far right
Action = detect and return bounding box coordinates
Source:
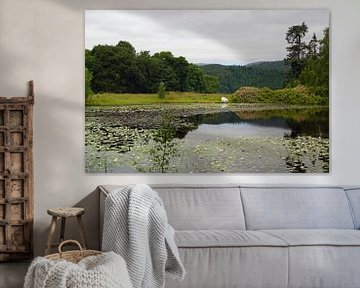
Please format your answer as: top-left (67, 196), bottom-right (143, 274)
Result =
top-left (262, 229), bottom-right (360, 246)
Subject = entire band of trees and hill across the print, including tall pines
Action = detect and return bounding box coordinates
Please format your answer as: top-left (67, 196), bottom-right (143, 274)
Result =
top-left (85, 22), bottom-right (329, 98)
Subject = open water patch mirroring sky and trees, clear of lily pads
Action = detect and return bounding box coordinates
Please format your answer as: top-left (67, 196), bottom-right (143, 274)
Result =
top-left (186, 108), bottom-right (329, 138)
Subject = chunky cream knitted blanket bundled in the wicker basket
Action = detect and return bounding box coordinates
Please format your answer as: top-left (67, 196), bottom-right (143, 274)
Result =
top-left (24, 252), bottom-right (132, 288)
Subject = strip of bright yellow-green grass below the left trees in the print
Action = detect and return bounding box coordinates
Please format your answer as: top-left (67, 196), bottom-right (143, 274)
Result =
top-left (86, 92), bottom-right (227, 106)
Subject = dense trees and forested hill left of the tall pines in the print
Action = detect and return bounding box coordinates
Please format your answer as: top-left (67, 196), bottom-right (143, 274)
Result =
top-left (85, 41), bottom-right (286, 93)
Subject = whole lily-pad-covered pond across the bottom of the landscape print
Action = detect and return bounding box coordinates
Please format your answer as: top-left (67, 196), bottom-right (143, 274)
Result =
top-left (85, 103), bottom-right (329, 173)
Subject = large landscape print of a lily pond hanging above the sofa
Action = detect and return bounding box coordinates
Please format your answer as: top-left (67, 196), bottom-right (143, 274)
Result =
top-left (85, 10), bottom-right (330, 173)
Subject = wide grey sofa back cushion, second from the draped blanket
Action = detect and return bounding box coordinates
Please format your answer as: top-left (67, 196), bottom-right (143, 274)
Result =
top-left (240, 187), bottom-right (354, 230)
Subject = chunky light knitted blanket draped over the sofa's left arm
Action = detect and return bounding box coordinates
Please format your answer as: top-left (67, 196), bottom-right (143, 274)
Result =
top-left (102, 184), bottom-right (185, 288)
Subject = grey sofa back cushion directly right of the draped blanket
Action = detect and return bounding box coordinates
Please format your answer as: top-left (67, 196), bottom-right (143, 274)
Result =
top-left (152, 185), bottom-right (245, 230)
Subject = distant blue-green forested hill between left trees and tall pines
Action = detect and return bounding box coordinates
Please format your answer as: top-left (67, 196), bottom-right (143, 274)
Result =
top-left (199, 61), bottom-right (287, 93)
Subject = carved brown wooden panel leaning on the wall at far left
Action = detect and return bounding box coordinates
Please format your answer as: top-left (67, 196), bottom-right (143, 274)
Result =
top-left (0, 81), bottom-right (34, 261)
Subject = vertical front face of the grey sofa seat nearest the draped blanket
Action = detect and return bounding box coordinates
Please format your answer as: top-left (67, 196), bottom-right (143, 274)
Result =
top-left (165, 246), bottom-right (288, 288)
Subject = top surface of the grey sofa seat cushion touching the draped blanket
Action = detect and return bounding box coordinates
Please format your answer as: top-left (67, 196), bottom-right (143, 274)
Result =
top-left (175, 230), bottom-right (288, 248)
